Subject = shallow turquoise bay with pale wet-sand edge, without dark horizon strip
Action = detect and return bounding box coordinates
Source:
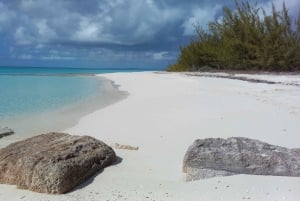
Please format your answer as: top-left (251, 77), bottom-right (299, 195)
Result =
top-left (0, 74), bottom-right (127, 144)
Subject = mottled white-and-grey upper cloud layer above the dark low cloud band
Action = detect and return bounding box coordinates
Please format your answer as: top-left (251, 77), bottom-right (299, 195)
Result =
top-left (0, 0), bottom-right (299, 46)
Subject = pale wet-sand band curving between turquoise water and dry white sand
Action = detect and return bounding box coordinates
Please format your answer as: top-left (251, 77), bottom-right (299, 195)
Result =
top-left (0, 75), bottom-right (128, 147)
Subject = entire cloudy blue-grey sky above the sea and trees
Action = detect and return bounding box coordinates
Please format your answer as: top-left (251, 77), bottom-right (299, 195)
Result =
top-left (0, 0), bottom-right (300, 68)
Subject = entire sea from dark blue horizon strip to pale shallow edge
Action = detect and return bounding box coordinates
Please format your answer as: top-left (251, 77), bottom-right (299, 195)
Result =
top-left (0, 67), bottom-right (162, 135)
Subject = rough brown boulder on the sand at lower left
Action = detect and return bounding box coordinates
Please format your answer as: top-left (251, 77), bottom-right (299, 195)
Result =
top-left (0, 133), bottom-right (116, 194)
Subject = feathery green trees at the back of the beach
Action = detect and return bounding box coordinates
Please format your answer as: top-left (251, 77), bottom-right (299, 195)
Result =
top-left (168, 1), bottom-right (300, 71)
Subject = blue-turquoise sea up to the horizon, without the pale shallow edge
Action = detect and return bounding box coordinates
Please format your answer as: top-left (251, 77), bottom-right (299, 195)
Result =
top-left (0, 67), bottom-right (159, 122)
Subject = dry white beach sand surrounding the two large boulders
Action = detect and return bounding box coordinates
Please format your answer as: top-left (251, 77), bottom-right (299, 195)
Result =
top-left (0, 72), bottom-right (300, 201)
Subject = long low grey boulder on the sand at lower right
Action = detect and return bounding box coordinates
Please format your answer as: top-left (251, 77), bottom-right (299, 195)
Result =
top-left (183, 137), bottom-right (300, 181)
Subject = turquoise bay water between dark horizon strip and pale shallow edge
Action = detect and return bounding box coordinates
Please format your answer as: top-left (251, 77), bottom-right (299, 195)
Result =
top-left (0, 75), bottom-right (102, 119)
